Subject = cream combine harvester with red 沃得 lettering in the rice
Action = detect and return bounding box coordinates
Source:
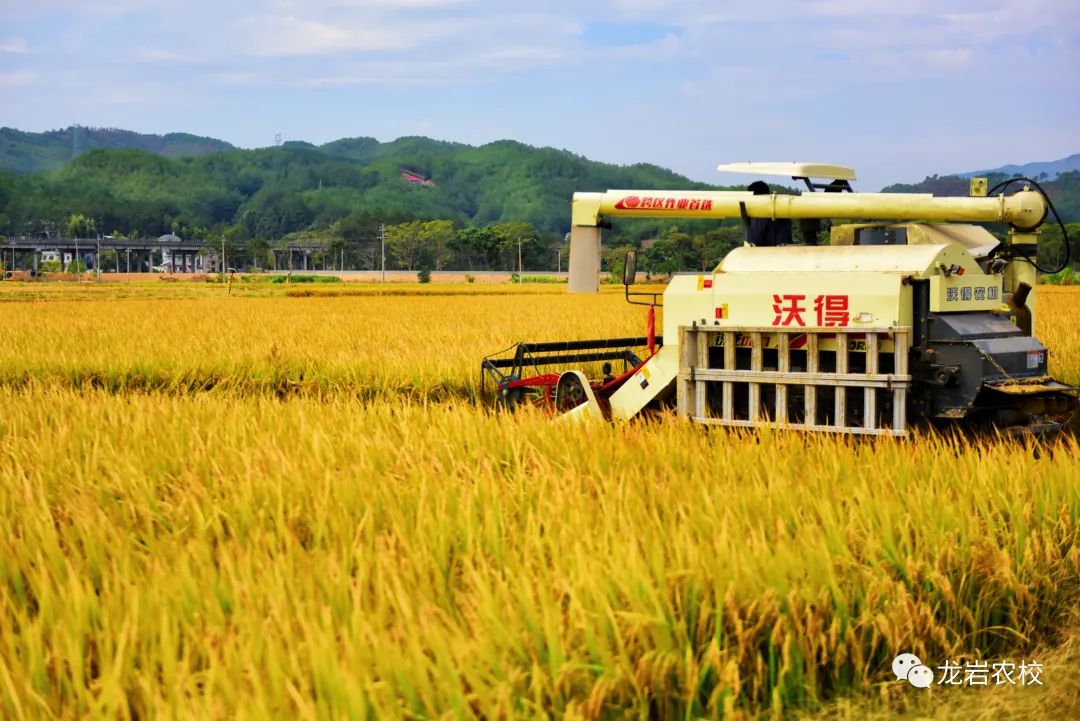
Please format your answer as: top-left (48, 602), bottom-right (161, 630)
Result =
top-left (482, 163), bottom-right (1078, 436)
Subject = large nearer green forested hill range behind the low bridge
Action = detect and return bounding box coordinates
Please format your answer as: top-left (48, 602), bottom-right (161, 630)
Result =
top-left (0, 132), bottom-right (706, 240)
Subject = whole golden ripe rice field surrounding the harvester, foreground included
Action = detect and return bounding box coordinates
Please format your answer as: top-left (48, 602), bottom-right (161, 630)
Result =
top-left (0, 284), bottom-right (1080, 719)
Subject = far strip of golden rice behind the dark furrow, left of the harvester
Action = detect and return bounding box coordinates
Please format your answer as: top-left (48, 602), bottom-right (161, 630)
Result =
top-left (0, 284), bottom-right (645, 400)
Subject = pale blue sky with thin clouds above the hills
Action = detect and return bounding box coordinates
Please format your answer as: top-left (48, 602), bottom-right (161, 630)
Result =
top-left (0, 0), bottom-right (1080, 190)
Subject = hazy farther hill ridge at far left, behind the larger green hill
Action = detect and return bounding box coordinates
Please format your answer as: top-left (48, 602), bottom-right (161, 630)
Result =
top-left (0, 125), bottom-right (235, 173)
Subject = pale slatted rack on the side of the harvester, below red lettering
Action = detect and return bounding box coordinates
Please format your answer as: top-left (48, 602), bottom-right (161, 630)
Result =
top-left (677, 324), bottom-right (912, 436)
